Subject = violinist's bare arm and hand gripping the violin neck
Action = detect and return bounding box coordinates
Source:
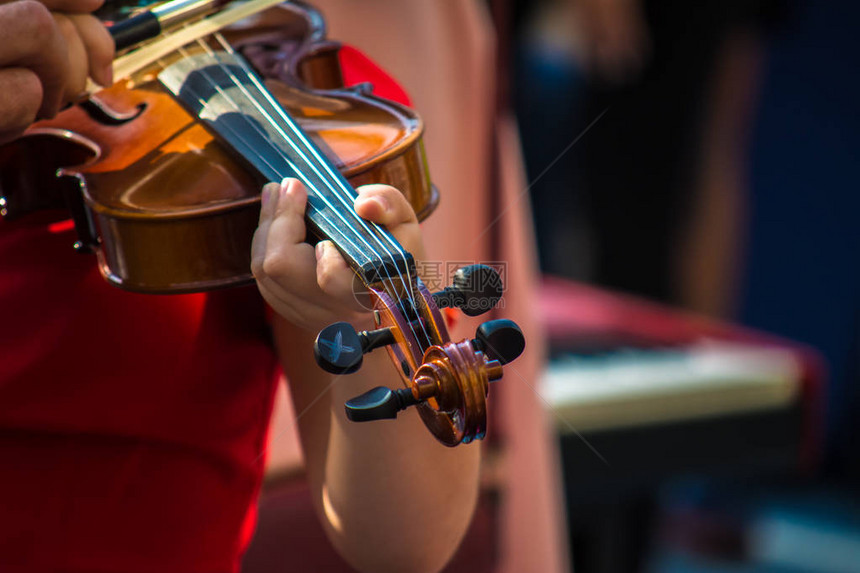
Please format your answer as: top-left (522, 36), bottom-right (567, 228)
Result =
top-left (253, 182), bottom-right (480, 573)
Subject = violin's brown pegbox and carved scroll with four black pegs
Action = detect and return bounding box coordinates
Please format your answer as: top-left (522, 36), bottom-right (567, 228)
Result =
top-left (314, 265), bottom-right (525, 446)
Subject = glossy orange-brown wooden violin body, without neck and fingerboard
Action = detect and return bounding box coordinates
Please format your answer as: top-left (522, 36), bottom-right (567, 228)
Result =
top-left (0, 4), bottom-right (438, 293)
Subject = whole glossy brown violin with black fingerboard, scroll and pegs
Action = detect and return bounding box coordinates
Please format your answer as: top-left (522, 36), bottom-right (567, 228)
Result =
top-left (0, 0), bottom-right (525, 446)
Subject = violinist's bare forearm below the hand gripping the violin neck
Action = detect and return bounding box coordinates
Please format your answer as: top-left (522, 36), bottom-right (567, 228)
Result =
top-left (274, 312), bottom-right (480, 573)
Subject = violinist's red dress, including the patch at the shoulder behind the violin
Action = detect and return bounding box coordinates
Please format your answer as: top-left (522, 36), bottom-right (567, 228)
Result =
top-left (0, 45), bottom-right (404, 573)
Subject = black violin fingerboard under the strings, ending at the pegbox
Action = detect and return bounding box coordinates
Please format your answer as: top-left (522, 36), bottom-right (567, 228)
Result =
top-left (159, 50), bottom-right (415, 285)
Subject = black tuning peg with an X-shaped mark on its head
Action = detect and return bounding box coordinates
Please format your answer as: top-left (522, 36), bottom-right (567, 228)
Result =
top-left (314, 322), bottom-right (394, 374)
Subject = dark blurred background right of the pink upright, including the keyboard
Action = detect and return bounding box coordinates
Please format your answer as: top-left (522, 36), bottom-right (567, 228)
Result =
top-left (500, 0), bottom-right (860, 573)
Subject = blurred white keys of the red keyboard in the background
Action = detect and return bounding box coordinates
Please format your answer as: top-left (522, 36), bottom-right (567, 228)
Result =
top-left (541, 340), bottom-right (801, 433)
